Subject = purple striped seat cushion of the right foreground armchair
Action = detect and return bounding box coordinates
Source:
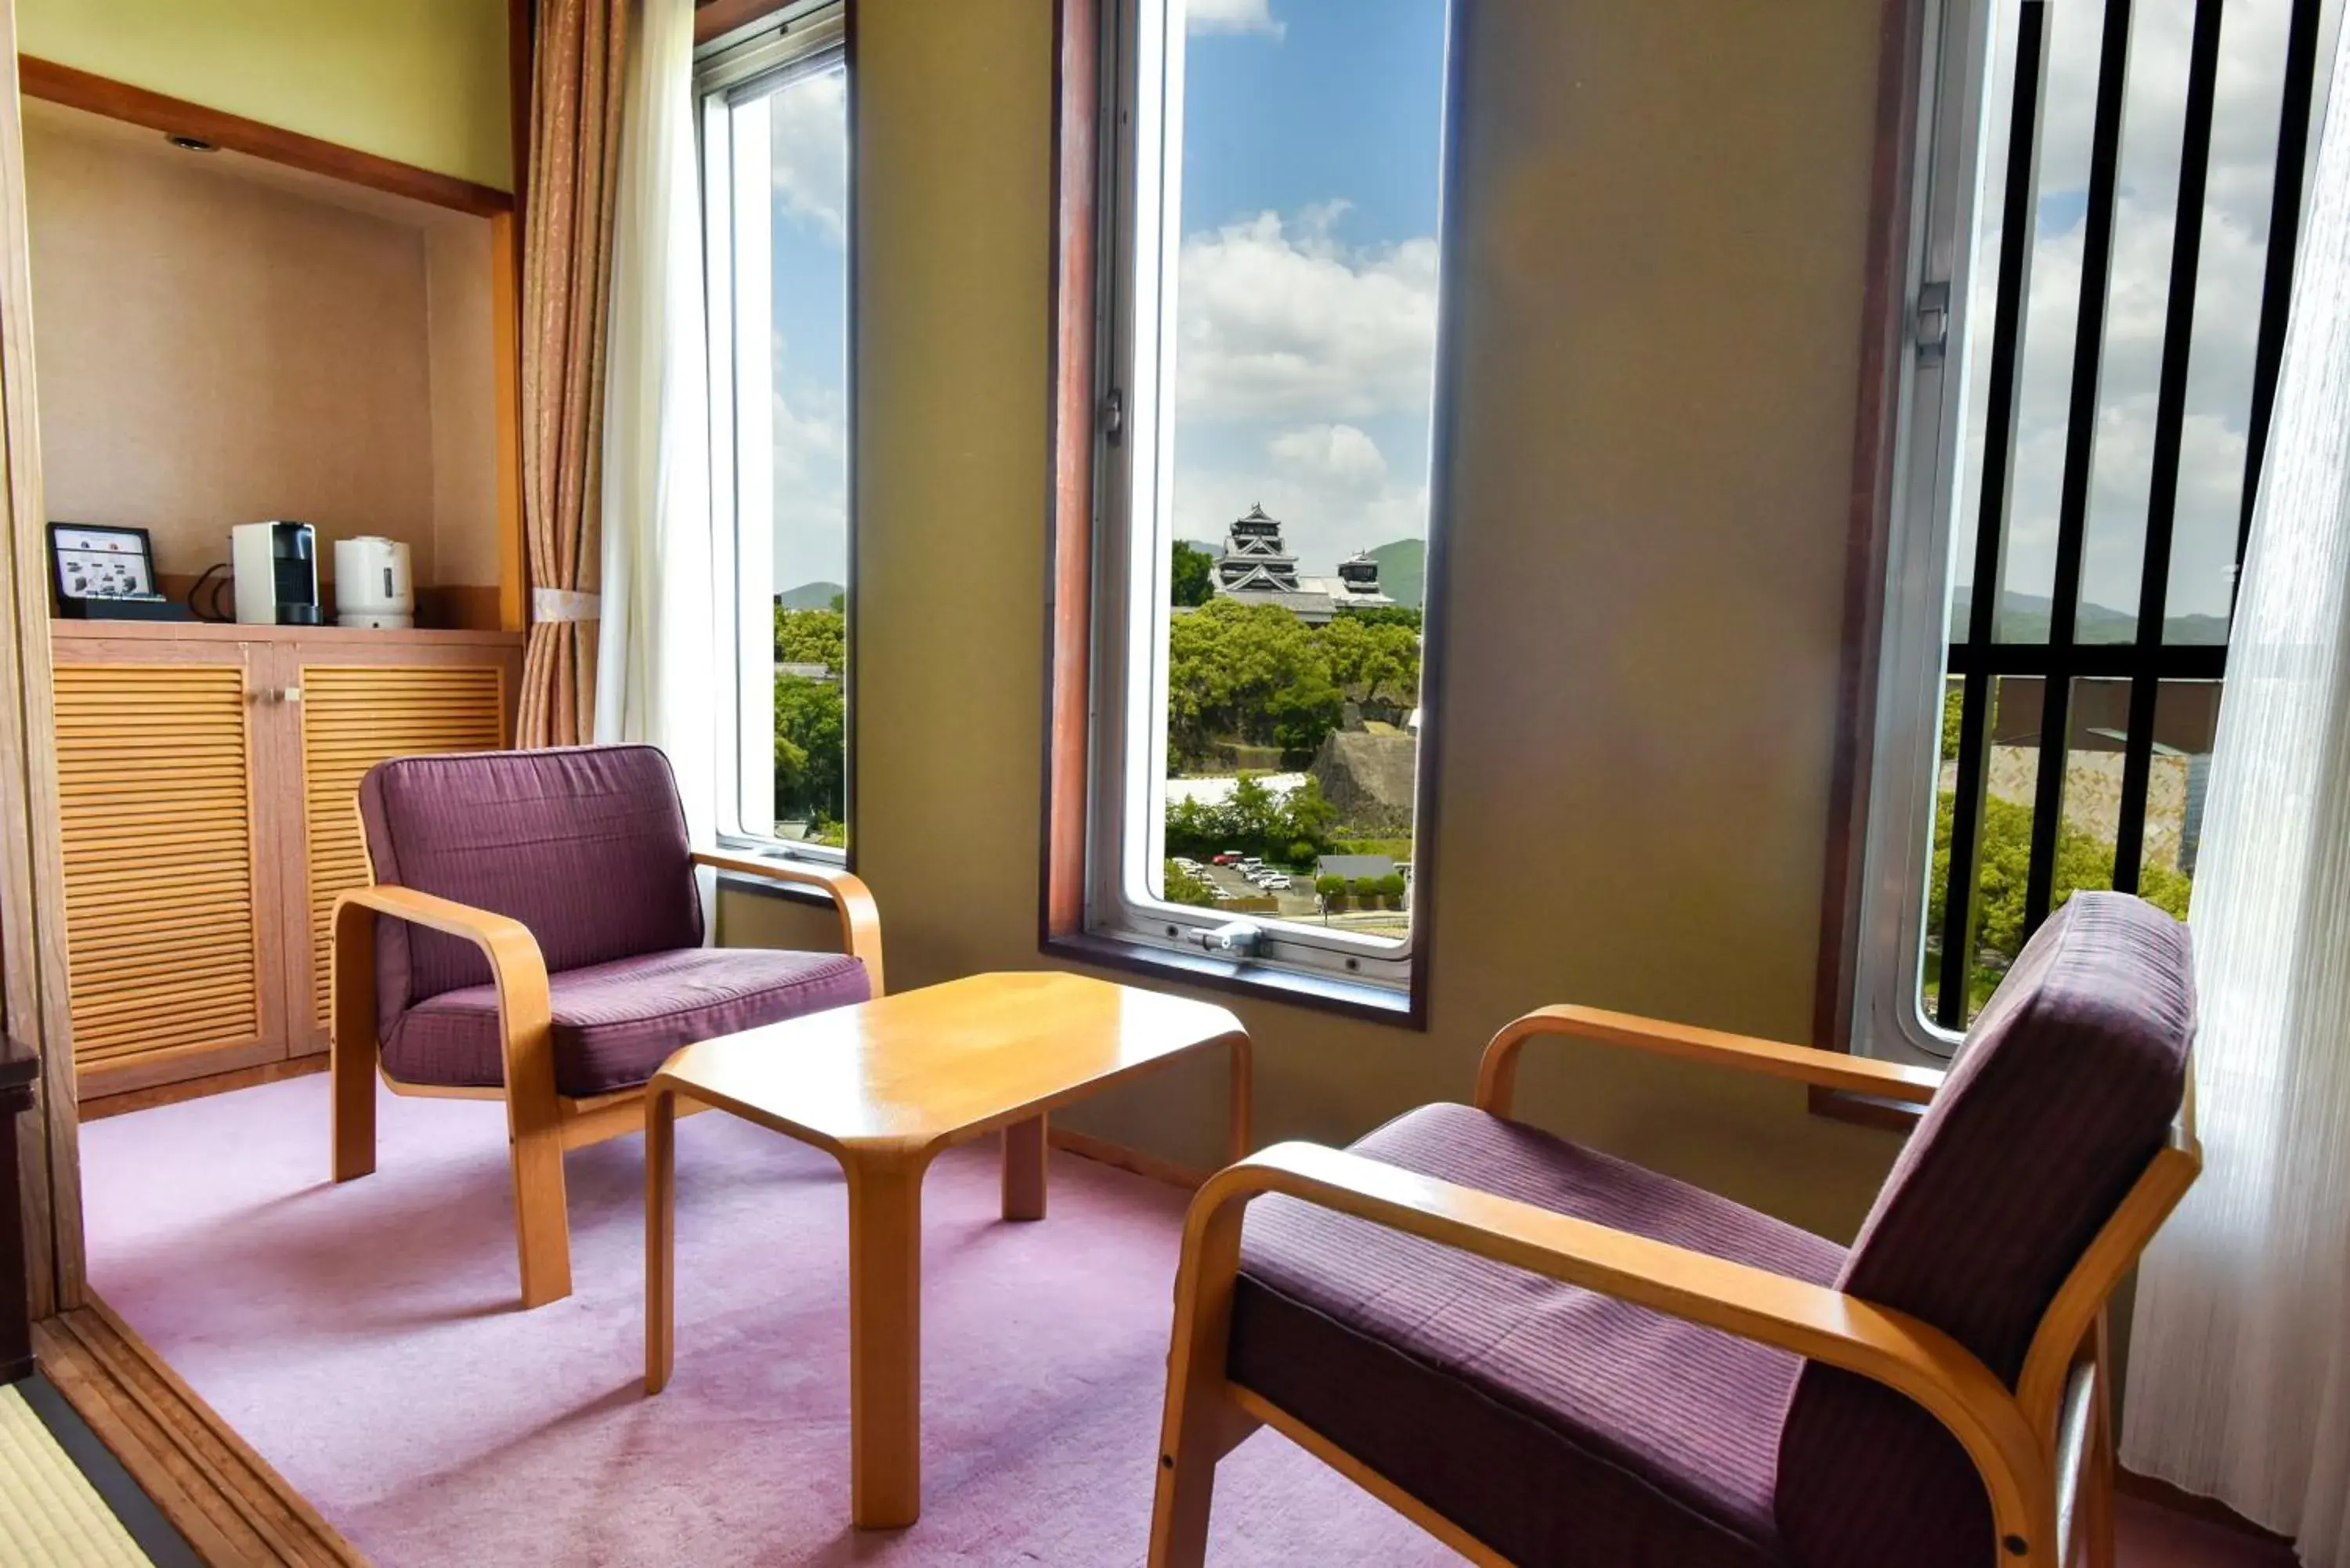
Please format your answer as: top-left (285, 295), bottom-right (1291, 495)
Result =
top-left (1229, 1105), bottom-right (1845, 1568)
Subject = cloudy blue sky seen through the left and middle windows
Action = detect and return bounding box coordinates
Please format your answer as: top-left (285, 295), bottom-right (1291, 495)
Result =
top-left (768, 0), bottom-right (1445, 587)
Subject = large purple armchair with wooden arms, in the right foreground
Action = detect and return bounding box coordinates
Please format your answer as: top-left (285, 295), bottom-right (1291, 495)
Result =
top-left (1152, 894), bottom-right (2200, 1568)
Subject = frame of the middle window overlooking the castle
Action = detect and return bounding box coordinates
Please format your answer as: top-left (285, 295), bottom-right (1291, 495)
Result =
top-left (1039, 0), bottom-right (1469, 1028)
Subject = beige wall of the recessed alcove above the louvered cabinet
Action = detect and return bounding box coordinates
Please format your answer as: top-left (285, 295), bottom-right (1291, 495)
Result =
top-left (26, 103), bottom-right (498, 594)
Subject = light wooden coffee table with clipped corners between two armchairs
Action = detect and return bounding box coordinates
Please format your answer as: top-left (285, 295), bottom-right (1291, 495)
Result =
top-left (644, 974), bottom-right (1248, 1528)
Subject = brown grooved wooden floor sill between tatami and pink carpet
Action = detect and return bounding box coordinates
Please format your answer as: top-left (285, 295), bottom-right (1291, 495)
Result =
top-left (33, 1298), bottom-right (367, 1568)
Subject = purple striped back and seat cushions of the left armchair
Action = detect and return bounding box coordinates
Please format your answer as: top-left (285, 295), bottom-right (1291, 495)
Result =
top-left (360, 745), bottom-right (872, 1096)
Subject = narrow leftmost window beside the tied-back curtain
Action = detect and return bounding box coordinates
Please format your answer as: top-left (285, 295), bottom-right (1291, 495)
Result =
top-left (696, 2), bottom-right (851, 858)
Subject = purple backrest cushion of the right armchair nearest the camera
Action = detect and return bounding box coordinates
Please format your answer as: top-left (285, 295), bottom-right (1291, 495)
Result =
top-left (1777, 894), bottom-right (2195, 1568)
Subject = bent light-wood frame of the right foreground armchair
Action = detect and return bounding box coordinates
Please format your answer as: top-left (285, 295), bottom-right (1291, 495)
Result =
top-left (1149, 1006), bottom-right (2202, 1568)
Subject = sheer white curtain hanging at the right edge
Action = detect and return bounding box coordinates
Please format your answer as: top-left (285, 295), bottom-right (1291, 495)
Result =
top-left (2122, 24), bottom-right (2350, 1568)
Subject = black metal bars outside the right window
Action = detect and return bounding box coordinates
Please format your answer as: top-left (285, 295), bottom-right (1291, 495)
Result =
top-left (1929, 0), bottom-right (2324, 1030)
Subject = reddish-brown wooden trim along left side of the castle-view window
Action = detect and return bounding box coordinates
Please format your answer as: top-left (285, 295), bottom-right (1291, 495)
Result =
top-left (1036, 0), bottom-right (1102, 943)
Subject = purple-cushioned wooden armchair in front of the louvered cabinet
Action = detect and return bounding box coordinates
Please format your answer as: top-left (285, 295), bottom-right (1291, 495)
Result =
top-left (334, 745), bottom-right (881, 1307)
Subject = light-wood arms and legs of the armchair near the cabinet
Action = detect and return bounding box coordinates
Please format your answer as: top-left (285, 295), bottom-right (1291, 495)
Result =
top-left (329, 851), bottom-right (881, 1310)
